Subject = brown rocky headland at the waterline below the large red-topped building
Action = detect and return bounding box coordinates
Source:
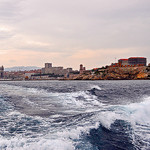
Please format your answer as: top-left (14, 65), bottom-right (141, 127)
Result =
top-left (66, 66), bottom-right (150, 80)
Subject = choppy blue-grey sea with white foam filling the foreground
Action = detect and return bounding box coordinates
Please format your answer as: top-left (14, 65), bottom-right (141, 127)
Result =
top-left (0, 80), bottom-right (150, 150)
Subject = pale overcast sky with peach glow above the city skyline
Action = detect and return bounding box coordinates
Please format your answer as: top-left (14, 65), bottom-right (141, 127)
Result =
top-left (0, 0), bottom-right (150, 69)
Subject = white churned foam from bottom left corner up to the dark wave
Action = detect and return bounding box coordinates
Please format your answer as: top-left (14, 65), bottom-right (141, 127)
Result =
top-left (0, 118), bottom-right (99, 150)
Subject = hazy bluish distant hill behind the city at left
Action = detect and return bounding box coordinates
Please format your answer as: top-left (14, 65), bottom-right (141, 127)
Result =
top-left (5, 66), bottom-right (41, 71)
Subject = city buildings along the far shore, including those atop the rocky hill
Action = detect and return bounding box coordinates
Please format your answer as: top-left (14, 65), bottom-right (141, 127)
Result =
top-left (0, 57), bottom-right (150, 80)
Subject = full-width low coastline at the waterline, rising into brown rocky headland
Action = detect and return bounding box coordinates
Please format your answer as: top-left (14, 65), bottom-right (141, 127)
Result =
top-left (0, 66), bottom-right (150, 81)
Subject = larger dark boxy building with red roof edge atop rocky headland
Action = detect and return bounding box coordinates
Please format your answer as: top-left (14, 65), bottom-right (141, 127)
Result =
top-left (128, 57), bottom-right (147, 66)
